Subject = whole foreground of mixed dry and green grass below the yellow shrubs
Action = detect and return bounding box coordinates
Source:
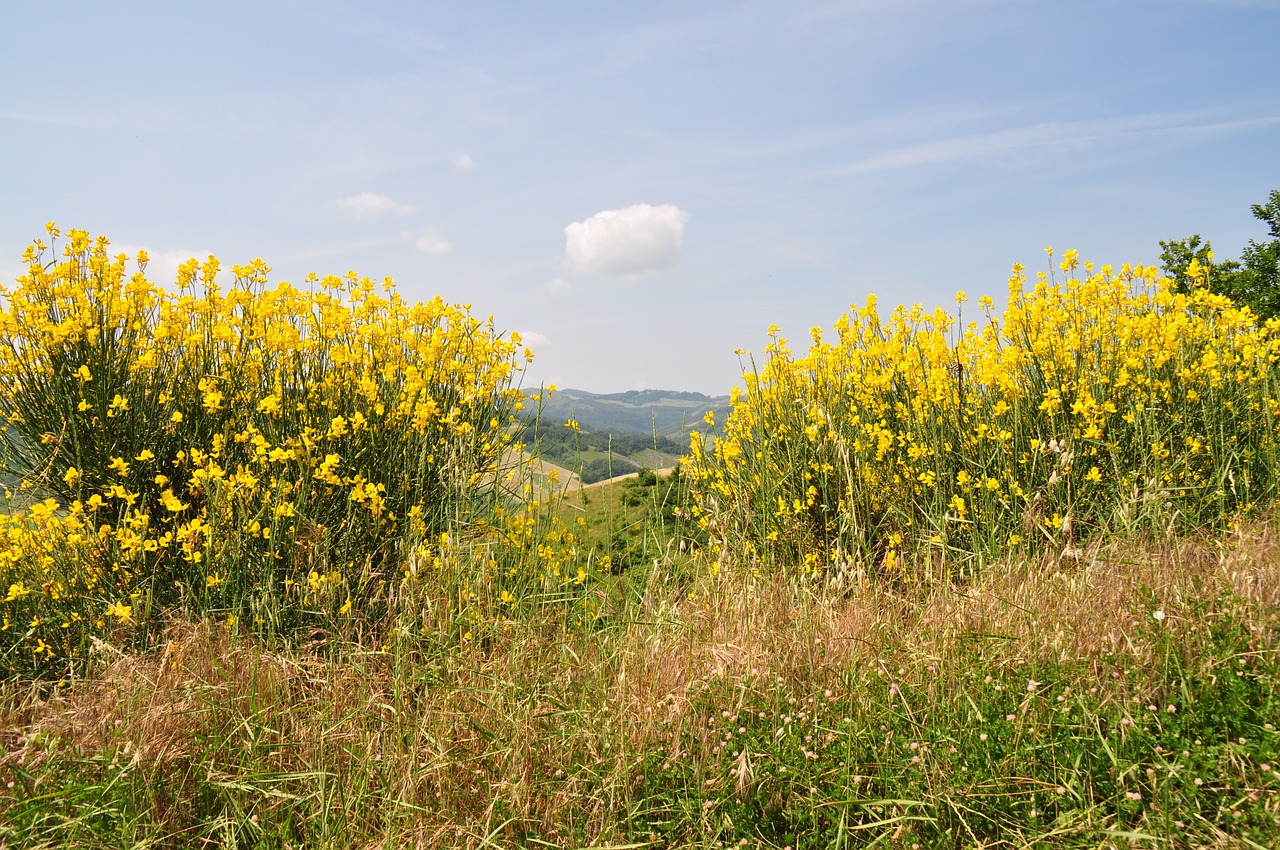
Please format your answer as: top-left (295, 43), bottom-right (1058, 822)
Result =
top-left (0, 484), bottom-right (1280, 847)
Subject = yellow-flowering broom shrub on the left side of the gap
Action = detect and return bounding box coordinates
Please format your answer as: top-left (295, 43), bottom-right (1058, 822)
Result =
top-left (0, 225), bottom-right (531, 668)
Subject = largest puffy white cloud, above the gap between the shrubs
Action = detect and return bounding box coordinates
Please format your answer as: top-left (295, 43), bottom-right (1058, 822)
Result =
top-left (564, 204), bottom-right (689, 277)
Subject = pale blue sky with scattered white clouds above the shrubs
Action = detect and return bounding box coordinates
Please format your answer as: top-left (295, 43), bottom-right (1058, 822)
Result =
top-left (0, 0), bottom-right (1280, 394)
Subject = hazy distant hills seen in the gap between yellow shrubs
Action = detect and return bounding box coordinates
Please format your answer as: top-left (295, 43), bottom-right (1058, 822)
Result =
top-left (522, 389), bottom-right (728, 484)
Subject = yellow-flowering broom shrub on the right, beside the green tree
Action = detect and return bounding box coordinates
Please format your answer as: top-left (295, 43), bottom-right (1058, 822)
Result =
top-left (687, 251), bottom-right (1280, 579)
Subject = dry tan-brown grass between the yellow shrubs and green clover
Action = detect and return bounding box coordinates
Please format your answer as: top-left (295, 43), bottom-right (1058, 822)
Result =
top-left (0, 524), bottom-right (1280, 847)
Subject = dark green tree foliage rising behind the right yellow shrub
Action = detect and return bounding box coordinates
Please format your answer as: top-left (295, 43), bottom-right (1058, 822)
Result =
top-left (1160, 189), bottom-right (1280, 321)
